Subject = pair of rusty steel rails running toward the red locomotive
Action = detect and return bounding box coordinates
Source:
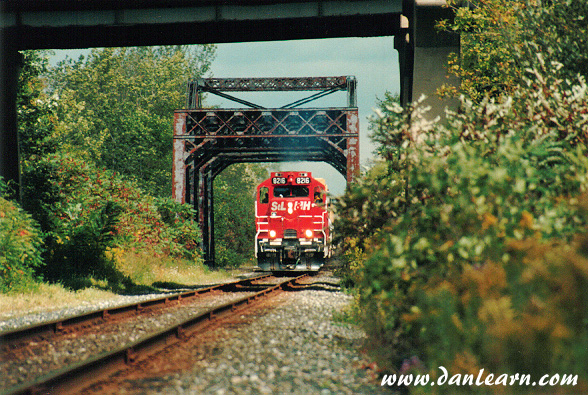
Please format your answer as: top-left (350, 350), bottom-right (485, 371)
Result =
top-left (0, 275), bottom-right (305, 395)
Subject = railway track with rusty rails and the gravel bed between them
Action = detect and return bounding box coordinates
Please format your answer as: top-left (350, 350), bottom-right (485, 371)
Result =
top-left (0, 275), bottom-right (308, 394)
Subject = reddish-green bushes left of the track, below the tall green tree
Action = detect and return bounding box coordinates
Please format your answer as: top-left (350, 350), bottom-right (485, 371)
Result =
top-left (26, 154), bottom-right (200, 286)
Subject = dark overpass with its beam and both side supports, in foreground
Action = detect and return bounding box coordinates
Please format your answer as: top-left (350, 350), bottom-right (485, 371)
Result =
top-left (0, 0), bottom-right (459, 190)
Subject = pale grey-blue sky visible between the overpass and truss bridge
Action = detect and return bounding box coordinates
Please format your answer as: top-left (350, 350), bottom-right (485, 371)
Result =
top-left (52, 37), bottom-right (400, 196)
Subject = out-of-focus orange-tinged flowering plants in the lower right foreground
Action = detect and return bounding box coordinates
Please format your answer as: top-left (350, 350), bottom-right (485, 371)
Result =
top-left (416, 230), bottom-right (588, 393)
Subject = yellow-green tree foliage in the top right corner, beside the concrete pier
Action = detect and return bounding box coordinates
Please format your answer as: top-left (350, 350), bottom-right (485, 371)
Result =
top-left (438, 0), bottom-right (588, 101)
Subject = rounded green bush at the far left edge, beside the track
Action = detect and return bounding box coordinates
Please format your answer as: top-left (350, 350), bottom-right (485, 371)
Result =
top-left (0, 179), bottom-right (43, 292)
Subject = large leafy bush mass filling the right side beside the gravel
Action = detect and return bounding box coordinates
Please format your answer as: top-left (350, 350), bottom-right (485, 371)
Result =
top-left (338, 24), bottom-right (588, 392)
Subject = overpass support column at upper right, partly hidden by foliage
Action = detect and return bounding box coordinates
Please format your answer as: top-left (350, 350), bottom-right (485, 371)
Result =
top-left (402, 0), bottom-right (459, 119)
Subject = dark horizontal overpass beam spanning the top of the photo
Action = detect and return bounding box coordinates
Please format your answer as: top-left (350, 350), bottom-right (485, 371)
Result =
top-left (0, 0), bottom-right (402, 49)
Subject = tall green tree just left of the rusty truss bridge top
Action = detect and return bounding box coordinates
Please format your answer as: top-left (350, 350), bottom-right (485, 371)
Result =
top-left (51, 45), bottom-right (216, 196)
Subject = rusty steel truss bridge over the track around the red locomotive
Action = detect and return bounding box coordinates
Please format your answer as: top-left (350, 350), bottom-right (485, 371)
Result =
top-left (173, 76), bottom-right (359, 265)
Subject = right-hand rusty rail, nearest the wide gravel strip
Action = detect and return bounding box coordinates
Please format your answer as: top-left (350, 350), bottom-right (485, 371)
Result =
top-left (0, 273), bottom-right (308, 395)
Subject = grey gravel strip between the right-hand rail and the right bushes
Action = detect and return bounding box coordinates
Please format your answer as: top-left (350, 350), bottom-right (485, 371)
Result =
top-left (112, 275), bottom-right (391, 395)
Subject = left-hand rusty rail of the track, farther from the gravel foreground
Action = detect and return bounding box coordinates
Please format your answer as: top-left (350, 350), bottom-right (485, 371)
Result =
top-left (0, 274), bottom-right (271, 349)
